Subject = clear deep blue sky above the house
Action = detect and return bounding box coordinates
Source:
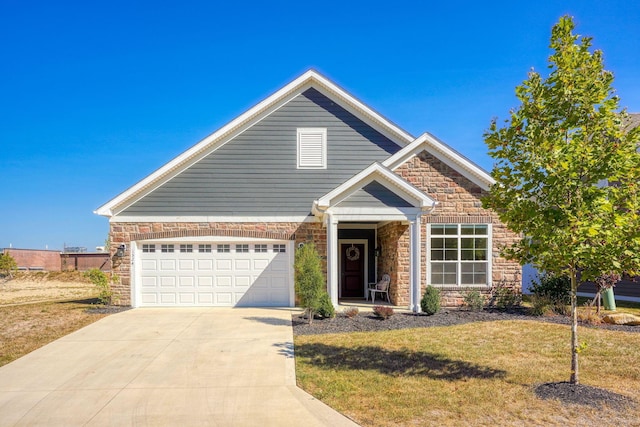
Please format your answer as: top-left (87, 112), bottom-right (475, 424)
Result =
top-left (0, 0), bottom-right (640, 250)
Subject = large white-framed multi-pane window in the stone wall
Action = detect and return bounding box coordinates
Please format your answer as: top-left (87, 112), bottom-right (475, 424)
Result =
top-left (428, 224), bottom-right (491, 286)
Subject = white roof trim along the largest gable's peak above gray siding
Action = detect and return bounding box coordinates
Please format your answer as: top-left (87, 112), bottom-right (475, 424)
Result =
top-left (94, 70), bottom-right (413, 217)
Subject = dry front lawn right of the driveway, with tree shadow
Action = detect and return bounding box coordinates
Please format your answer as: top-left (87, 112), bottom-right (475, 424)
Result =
top-left (295, 321), bottom-right (640, 426)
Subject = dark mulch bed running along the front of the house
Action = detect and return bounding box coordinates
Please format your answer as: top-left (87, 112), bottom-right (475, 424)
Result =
top-left (292, 308), bottom-right (640, 335)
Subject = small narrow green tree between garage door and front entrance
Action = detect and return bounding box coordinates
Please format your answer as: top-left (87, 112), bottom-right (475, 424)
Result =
top-left (294, 243), bottom-right (326, 323)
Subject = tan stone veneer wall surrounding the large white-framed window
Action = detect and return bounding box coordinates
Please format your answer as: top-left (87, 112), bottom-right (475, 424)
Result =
top-left (395, 151), bottom-right (522, 306)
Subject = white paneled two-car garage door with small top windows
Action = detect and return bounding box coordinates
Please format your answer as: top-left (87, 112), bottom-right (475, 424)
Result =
top-left (139, 241), bottom-right (293, 307)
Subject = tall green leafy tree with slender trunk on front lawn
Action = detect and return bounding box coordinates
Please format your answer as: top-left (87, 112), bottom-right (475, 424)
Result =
top-left (483, 16), bottom-right (640, 384)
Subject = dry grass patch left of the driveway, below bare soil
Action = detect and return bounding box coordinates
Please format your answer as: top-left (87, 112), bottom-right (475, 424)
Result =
top-left (0, 302), bottom-right (107, 366)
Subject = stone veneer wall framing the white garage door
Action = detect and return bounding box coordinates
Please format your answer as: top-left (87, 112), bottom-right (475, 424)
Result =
top-left (110, 222), bottom-right (327, 305)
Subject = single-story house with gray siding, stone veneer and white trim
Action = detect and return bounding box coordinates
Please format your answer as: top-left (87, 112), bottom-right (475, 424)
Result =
top-left (95, 70), bottom-right (521, 311)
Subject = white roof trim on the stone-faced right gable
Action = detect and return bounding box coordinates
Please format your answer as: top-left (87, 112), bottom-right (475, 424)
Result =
top-left (382, 132), bottom-right (495, 190)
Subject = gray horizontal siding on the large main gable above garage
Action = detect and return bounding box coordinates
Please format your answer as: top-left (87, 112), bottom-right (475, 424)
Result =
top-left (121, 89), bottom-right (401, 216)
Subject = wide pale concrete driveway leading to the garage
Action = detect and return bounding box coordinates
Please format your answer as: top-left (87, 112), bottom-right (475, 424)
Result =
top-left (0, 308), bottom-right (356, 427)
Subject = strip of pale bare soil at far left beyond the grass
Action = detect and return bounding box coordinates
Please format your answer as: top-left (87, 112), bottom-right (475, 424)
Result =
top-left (0, 272), bottom-right (98, 306)
